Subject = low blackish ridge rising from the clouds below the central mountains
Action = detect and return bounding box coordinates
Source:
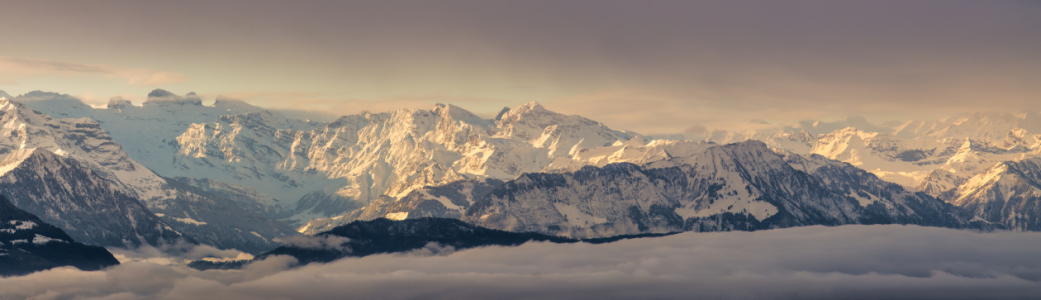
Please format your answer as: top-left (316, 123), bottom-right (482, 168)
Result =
top-left (188, 218), bottom-right (677, 270)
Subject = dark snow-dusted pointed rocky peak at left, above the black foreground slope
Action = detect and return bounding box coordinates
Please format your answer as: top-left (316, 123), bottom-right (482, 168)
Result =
top-left (0, 149), bottom-right (185, 248)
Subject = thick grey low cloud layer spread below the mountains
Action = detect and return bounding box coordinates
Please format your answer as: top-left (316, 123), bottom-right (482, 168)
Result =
top-left (0, 225), bottom-right (1041, 299)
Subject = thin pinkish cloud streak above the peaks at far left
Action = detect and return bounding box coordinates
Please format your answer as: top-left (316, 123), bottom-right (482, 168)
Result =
top-left (0, 56), bottom-right (188, 86)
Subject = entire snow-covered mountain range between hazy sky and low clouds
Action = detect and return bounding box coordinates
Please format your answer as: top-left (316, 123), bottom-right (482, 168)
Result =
top-left (0, 90), bottom-right (1041, 258)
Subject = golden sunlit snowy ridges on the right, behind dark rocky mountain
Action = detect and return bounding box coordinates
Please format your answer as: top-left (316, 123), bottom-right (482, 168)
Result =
top-left (695, 113), bottom-right (1041, 230)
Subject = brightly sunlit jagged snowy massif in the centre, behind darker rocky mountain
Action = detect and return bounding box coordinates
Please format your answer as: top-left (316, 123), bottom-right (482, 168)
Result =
top-left (175, 103), bottom-right (642, 221)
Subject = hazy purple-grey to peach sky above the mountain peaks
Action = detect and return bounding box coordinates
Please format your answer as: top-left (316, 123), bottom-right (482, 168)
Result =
top-left (0, 0), bottom-right (1041, 133)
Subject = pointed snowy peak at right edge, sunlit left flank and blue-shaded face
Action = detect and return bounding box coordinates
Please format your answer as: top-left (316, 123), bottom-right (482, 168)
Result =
top-left (951, 158), bottom-right (1041, 231)
